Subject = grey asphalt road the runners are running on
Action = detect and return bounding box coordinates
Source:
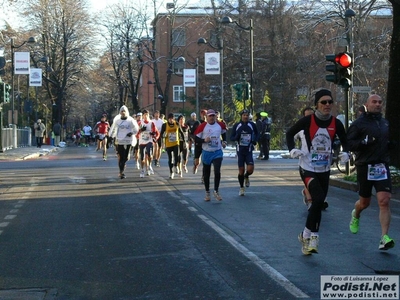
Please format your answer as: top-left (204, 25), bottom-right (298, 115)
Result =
top-left (0, 147), bottom-right (400, 299)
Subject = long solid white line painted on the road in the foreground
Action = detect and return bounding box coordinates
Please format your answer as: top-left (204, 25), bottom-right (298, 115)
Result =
top-left (198, 215), bottom-right (310, 298)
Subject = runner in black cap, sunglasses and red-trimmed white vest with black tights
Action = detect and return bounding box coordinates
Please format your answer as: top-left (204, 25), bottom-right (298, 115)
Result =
top-left (286, 89), bottom-right (349, 255)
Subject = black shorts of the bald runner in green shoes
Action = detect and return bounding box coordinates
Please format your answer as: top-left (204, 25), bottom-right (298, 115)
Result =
top-left (357, 164), bottom-right (392, 198)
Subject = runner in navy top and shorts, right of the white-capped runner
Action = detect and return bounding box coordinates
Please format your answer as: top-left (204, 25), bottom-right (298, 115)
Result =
top-left (231, 109), bottom-right (258, 196)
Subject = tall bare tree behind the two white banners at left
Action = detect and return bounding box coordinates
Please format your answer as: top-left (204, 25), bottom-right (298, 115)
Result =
top-left (24, 0), bottom-right (93, 129)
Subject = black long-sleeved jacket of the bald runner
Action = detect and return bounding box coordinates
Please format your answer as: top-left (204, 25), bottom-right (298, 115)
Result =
top-left (347, 112), bottom-right (390, 165)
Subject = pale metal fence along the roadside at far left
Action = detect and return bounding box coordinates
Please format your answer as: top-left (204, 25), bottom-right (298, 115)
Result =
top-left (0, 125), bottom-right (32, 152)
